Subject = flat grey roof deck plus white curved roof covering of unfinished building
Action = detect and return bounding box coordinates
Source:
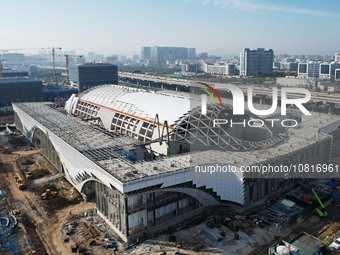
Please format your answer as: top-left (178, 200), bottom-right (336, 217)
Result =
top-left (15, 86), bottom-right (340, 181)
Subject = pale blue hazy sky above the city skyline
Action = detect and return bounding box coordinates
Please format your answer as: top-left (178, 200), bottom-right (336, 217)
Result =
top-left (0, 0), bottom-right (340, 55)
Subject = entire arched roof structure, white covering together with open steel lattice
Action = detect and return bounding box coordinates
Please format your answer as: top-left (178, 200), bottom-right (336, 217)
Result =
top-left (66, 85), bottom-right (288, 154)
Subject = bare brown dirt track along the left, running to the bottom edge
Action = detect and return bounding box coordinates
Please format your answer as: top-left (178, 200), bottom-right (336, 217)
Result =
top-left (0, 152), bottom-right (95, 255)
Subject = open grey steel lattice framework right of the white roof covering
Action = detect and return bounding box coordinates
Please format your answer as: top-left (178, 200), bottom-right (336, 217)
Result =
top-left (171, 104), bottom-right (288, 151)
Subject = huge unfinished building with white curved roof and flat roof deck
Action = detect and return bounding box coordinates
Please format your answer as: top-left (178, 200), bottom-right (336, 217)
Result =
top-left (13, 85), bottom-right (340, 241)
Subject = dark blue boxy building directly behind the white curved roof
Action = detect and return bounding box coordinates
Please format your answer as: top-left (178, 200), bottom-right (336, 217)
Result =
top-left (70, 63), bottom-right (118, 92)
